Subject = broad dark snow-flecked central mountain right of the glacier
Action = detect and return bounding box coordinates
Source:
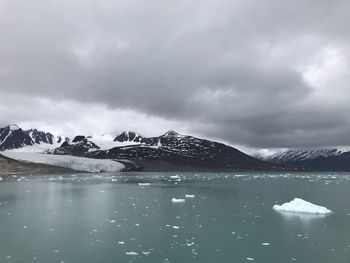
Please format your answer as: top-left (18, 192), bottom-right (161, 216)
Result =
top-left (51, 130), bottom-right (276, 170)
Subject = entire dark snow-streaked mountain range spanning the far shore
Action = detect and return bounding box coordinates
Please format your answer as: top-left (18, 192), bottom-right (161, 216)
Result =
top-left (0, 125), bottom-right (350, 171)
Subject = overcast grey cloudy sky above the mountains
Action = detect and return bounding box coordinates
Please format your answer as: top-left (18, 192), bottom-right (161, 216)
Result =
top-left (0, 0), bottom-right (350, 153)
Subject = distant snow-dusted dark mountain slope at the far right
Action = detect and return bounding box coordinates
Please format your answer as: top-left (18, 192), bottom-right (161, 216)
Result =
top-left (260, 148), bottom-right (350, 171)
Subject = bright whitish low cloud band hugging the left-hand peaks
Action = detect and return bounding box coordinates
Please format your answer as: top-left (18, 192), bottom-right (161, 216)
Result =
top-left (0, 96), bottom-right (188, 137)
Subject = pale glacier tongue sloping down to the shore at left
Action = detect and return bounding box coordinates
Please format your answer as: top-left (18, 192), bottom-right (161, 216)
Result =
top-left (2, 150), bottom-right (125, 173)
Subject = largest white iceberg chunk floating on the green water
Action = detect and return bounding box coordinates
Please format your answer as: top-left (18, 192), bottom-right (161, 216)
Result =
top-left (273, 198), bottom-right (332, 214)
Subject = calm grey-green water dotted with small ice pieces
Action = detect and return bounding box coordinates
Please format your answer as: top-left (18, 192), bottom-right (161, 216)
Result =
top-left (0, 173), bottom-right (350, 263)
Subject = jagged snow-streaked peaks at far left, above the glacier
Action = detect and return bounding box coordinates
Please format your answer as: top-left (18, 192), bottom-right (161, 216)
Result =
top-left (0, 125), bottom-right (66, 151)
